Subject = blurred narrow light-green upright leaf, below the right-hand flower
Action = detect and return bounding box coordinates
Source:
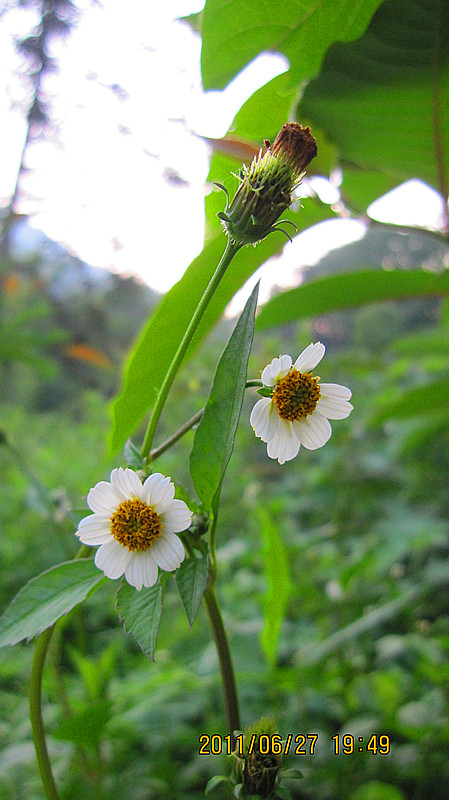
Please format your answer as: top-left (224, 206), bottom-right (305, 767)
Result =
top-left (258, 508), bottom-right (292, 665)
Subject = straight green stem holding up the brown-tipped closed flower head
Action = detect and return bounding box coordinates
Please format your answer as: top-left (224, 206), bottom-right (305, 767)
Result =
top-left (142, 238), bottom-right (242, 458)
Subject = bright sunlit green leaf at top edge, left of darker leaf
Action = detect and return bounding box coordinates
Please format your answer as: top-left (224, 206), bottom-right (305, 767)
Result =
top-left (201, 0), bottom-right (382, 89)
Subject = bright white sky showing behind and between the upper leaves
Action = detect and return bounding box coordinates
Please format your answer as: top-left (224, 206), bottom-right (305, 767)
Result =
top-left (0, 0), bottom-right (441, 298)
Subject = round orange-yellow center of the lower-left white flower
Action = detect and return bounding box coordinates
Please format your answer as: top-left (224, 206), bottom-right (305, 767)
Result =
top-left (111, 498), bottom-right (162, 552)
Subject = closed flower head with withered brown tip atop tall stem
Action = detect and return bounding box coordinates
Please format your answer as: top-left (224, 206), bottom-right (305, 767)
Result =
top-left (218, 122), bottom-right (317, 245)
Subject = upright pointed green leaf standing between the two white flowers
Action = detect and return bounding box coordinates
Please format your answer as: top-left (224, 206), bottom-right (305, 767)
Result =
top-left (190, 284), bottom-right (259, 509)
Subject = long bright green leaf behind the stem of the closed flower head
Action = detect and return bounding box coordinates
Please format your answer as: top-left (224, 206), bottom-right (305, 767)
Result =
top-left (111, 199), bottom-right (328, 451)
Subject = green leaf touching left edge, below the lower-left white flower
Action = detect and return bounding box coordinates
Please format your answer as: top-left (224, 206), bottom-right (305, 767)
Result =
top-left (0, 558), bottom-right (106, 647)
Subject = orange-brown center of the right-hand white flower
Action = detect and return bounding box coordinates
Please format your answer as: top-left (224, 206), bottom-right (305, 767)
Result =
top-left (272, 367), bottom-right (321, 422)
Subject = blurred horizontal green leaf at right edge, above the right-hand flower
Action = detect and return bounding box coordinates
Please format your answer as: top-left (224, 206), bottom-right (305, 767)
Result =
top-left (256, 269), bottom-right (449, 330)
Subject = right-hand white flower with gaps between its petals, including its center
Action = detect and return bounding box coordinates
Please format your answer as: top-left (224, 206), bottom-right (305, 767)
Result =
top-left (250, 342), bottom-right (353, 464)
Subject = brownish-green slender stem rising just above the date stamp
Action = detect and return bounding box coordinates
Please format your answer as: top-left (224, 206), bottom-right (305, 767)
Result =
top-left (203, 585), bottom-right (241, 736)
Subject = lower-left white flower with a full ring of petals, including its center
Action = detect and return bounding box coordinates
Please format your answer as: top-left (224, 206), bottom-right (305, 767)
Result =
top-left (76, 467), bottom-right (192, 590)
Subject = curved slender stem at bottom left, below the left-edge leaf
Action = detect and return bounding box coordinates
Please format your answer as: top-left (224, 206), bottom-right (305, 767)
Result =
top-left (29, 626), bottom-right (59, 800)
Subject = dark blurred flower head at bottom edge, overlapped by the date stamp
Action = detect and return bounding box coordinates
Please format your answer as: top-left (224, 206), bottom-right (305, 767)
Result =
top-left (235, 717), bottom-right (282, 797)
